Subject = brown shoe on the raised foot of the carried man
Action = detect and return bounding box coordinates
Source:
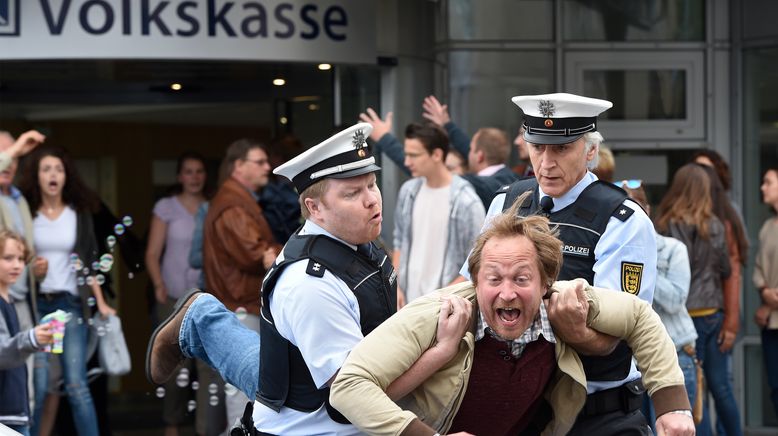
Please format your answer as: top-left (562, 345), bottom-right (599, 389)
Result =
top-left (146, 289), bottom-right (203, 385)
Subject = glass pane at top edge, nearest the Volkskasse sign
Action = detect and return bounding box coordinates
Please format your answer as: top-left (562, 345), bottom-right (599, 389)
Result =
top-left (448, 0), bottom-right (554, 41)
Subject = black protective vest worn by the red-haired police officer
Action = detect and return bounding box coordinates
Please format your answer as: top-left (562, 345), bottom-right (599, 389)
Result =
top-left (256, 234), bottom-right (397, 422)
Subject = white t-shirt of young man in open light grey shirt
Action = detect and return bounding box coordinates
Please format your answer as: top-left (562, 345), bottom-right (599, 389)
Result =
top-left (404, 183), bottom-right (451, 303)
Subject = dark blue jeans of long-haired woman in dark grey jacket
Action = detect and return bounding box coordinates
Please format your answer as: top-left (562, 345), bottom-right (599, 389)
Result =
top-left (692, 312), bottom-right (743, 436)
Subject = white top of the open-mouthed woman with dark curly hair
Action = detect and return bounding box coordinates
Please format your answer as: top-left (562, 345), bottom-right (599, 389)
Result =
top-left (32, 206), bottom-right (77, 296)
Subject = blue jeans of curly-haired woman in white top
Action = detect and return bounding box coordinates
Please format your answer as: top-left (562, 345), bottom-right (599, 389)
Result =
top-left (32, 295), bottom-right (99, 436)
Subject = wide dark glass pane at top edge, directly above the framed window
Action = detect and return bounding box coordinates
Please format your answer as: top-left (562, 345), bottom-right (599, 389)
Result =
top-left (562, 0), bottom-right (705, 41)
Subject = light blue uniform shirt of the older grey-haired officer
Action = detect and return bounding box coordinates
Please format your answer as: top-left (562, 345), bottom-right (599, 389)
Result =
top-left (460, 171), bottom-right (656, 393)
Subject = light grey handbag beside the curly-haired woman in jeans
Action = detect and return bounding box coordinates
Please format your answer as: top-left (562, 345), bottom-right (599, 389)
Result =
top-left (92, 314), bottom-right (132, 375)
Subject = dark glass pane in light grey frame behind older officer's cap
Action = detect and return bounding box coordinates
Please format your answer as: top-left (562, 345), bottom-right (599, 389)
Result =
top-left (583, 70), bottom-right (687, 120)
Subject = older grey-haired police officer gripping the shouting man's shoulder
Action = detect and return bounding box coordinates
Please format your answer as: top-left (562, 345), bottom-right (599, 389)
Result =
top-left (463, 93), bottom-right (660, 435)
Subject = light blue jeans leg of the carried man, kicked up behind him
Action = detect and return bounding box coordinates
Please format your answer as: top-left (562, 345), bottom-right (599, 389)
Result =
top-left (178, 294), bottom-right (259, 398)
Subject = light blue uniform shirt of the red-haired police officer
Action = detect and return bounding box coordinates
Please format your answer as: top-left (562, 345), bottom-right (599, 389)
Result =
top-left (253, 221), bottom-right (362, 435)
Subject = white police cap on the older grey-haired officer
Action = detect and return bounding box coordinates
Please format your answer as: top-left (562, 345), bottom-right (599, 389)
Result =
top-left (511, 93), bottom-right (613, 144)
